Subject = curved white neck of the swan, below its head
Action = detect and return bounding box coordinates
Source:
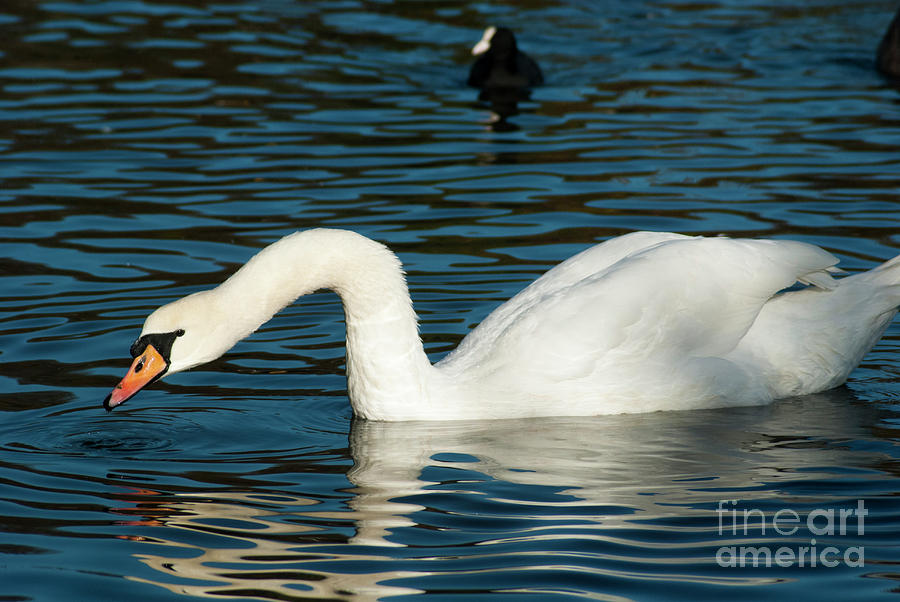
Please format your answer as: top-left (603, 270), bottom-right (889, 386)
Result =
top-left (223, 229), bottom-right (434, 419)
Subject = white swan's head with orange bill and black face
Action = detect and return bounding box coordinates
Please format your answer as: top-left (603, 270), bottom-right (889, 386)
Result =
top-left (103, 291), bottom-right (239, 410)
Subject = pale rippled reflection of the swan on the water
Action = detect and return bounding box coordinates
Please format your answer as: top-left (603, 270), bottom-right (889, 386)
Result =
top-left (118, 389), bottom-right (884, 600)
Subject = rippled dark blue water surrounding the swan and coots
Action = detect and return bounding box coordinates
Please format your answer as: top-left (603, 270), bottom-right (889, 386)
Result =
top-left (0, 0), bottom-right (900, 601)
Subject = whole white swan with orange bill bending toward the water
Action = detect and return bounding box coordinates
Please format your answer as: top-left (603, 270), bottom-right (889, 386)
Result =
top-left (104, 229), bottom-right (900, 420)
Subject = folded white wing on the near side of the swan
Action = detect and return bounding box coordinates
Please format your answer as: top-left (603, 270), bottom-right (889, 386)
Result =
top-left (442, 235), bottom-right (837, 386)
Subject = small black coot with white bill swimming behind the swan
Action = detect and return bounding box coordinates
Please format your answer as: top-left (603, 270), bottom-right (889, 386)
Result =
top-left (468, 27), bottom-right (544, 90)
